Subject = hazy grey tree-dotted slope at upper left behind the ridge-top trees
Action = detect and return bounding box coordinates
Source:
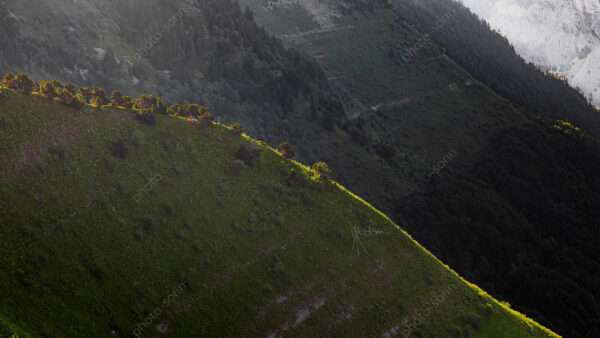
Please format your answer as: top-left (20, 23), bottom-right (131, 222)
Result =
top-left (0, 0), bottom-right (343, 153)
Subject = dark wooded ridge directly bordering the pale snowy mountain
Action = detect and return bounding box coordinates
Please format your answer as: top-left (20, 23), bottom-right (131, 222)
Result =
top-left (392, 0), bottom-right (600, 135)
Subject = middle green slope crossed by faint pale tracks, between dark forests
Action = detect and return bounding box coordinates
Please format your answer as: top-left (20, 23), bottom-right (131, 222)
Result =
top-left (241, 0), bottom-right (526, 203)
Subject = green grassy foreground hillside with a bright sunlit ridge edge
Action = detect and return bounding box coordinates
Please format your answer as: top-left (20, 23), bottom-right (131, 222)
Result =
top-left (0, 89), bottom-right (553, 337)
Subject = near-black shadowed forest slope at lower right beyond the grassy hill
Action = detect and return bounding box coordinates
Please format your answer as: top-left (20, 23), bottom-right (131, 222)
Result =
top-left (404, 121), bottom-right (600, 337)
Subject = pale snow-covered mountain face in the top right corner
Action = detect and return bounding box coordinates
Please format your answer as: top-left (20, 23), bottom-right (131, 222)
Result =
top-left (462, 0), bottom-right (600, 106)
